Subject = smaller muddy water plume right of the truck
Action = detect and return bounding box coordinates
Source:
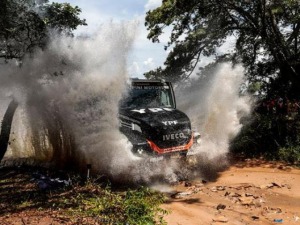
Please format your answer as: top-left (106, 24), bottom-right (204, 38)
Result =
top-left (177, 63), bottom-right (251, 179)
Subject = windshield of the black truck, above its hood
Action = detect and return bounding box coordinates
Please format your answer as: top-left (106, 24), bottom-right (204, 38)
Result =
top-left (121, 85), bottom-right (175, 108)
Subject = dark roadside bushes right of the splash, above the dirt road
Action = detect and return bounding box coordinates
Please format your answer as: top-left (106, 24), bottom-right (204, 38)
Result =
top-left (231, 103), bottom-right (300, 166)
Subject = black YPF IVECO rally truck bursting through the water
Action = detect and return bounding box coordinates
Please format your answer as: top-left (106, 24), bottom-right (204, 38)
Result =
top-left (119, 79), bottom-right (200, 156)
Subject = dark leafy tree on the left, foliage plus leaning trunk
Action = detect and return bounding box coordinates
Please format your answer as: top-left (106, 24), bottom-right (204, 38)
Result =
top-left (0, 0), bottom-right (86, 161)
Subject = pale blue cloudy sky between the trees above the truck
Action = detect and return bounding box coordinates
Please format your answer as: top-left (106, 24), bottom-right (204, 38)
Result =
top-left (55, 0), bottom-right (168, 78)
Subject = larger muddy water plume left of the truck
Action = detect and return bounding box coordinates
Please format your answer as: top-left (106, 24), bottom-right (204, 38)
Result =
top-left (0, 23), bottom-right (136, 173)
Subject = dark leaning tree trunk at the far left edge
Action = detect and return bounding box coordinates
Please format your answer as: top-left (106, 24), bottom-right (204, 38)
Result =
top-left (0, 100), bottom-right (18, 162)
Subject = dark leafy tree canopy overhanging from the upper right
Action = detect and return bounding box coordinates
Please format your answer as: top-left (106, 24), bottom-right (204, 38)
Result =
top-left (145, 0), bottom-right (300, 95)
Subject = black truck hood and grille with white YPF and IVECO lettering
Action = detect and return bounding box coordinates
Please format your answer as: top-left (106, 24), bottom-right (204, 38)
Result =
top-left (119, 108), bottom-right (192, 153)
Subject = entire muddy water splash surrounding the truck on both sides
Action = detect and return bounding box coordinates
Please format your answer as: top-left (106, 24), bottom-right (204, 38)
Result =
top-left (0, 23), bottom-right (250, 183)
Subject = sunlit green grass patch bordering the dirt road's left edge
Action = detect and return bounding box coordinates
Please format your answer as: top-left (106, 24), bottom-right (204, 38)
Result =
top-left (60, 183), bottom-right (167, 225)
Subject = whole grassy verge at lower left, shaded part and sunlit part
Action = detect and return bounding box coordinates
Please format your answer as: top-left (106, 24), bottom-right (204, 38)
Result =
top-left (0, 168), bottom-right (167, 225)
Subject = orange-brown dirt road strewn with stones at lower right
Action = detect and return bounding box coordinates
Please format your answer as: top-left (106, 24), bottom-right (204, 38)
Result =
top-left (163, 160), bottom-right (300, 225)
